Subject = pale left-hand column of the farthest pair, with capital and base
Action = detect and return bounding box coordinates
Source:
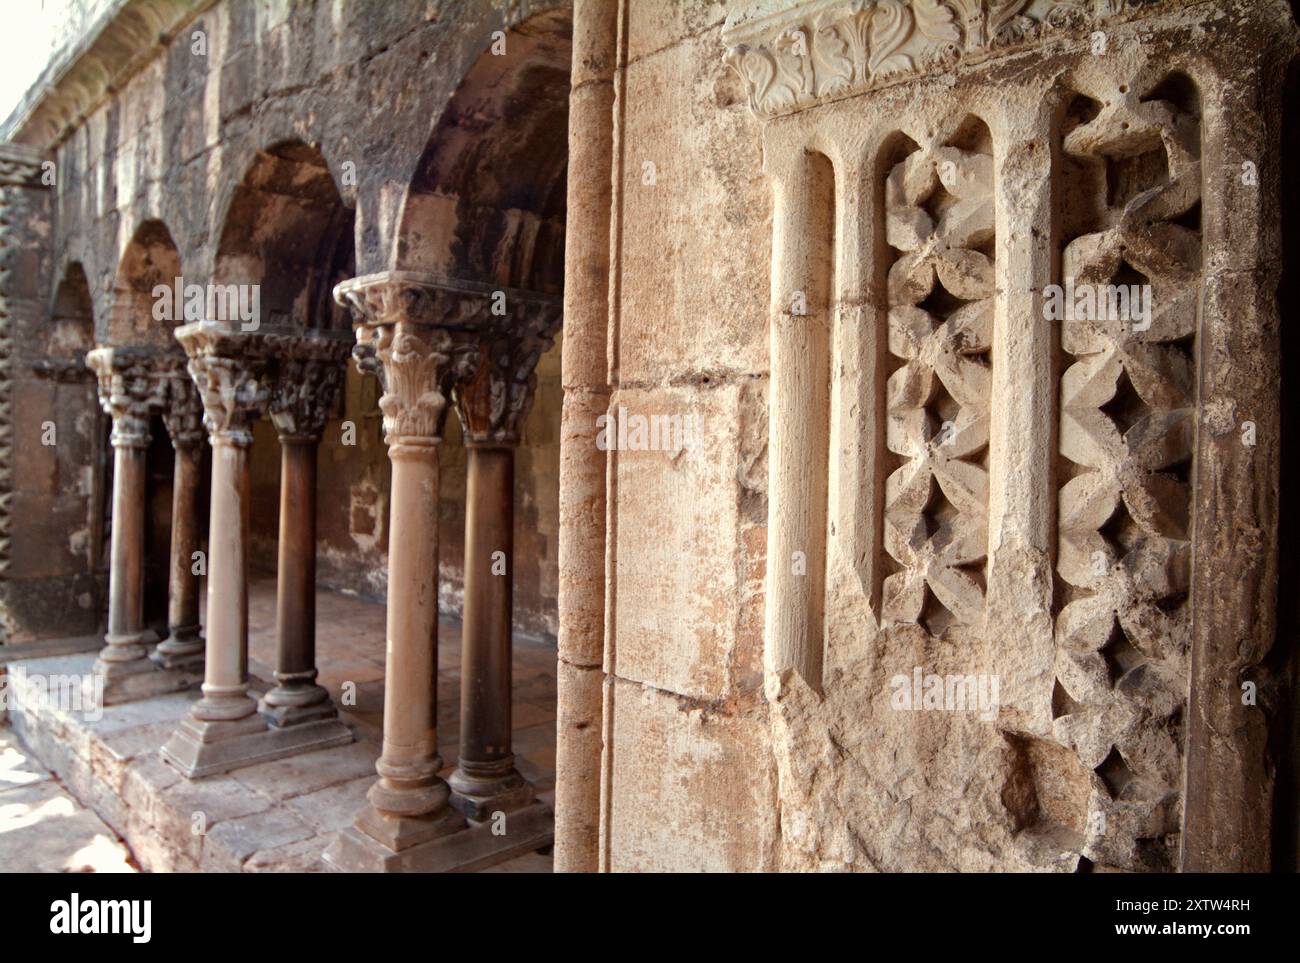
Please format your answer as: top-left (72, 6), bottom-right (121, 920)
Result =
top-left (86, 347), bottom-right (196, 704)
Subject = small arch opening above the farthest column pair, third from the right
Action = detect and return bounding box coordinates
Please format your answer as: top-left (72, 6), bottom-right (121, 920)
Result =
top-left (108, 220), bottom-right (182, 348)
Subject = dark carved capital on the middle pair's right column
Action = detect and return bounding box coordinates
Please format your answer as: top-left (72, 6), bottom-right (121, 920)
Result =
top-left (269, 335), bottom-right (354, 441)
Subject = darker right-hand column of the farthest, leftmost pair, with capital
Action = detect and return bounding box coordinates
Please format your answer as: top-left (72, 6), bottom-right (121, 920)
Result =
top-left (151, 357), bottom-right (203, 672)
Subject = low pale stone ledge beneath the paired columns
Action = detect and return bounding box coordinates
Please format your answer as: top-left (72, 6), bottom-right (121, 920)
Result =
top-left (9, 654), bottom-right (554, 872)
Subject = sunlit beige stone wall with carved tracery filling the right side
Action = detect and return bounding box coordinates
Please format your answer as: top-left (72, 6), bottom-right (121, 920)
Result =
top-left (556, 0), bottom-right (1296, 871)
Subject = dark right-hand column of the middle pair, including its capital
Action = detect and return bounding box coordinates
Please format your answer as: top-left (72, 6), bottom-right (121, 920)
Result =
top-left (259, 337), bottom-right (352, 741)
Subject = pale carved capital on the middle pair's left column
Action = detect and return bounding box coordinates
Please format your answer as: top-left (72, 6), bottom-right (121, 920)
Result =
top-left (176, 321), bottom-right (272, 447)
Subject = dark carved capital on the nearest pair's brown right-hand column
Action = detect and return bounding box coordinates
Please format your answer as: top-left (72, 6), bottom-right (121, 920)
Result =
top-left (452, 302), bottom-right (562, 446)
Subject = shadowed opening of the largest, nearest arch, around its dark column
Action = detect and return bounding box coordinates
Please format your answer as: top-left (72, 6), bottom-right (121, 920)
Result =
top-left (384, 6), bottom-right (572, 637)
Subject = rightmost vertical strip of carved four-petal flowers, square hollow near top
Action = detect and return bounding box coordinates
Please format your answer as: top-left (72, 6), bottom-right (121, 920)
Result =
top-left (1054, 74), bottom-right (1201, 869)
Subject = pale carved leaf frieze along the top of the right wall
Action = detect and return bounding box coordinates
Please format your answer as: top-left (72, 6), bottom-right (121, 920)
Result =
top-left (724, 0), bottom-right (1151, 116)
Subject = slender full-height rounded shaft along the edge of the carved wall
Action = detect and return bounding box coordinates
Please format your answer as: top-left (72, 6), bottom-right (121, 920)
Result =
top-left (555, 0), bottom-right (623, 872)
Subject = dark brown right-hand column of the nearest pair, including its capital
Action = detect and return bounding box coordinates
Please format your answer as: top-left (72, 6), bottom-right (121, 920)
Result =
top-left (450, 302), bottom-right (560, 820)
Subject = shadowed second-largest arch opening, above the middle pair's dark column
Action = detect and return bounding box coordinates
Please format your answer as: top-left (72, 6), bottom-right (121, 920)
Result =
top-left (212, 140), bottom-right (356, 330)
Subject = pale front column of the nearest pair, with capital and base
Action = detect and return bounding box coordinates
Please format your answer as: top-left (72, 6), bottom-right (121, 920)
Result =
top-left (325, 272), bottom-right (547, 872)
